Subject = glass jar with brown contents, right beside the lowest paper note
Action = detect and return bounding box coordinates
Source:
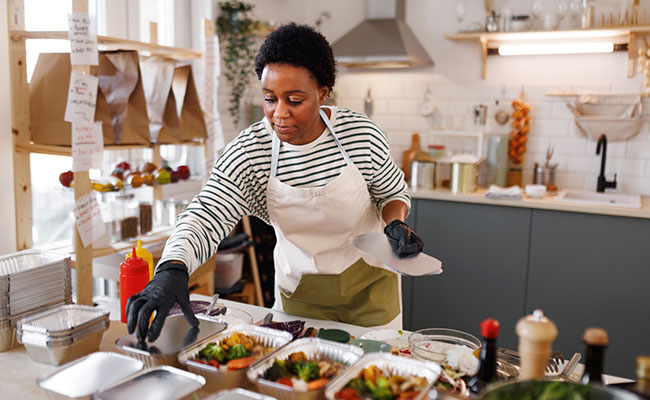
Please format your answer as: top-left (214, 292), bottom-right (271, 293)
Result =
top-left (107, 191), bottom-right (140, 242)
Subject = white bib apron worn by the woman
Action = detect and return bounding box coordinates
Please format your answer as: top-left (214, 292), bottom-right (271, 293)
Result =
top-left (265, 110), bottom-right (402, 329)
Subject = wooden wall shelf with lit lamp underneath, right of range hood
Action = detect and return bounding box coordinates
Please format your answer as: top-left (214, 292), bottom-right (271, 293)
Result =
top-left (445, 25), bottom-right (650, 79)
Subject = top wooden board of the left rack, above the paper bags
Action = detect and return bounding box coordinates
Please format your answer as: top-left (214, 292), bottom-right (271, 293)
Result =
top-left (9, 30), bottom-right (201, 58)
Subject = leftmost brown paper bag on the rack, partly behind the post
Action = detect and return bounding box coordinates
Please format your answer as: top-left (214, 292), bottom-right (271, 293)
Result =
top-left (29, 53), bottom-right (115, 146)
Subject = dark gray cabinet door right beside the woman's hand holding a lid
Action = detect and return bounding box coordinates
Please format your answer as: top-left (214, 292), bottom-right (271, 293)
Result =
top-left (404, 199), bottom-right (531, 348)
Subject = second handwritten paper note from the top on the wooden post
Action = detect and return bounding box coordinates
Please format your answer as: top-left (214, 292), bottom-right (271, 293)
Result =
top-left (63, 71), bottom-right (99, 123)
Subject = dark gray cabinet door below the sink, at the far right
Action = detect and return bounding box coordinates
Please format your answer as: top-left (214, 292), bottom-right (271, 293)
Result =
top-left (526, 210), bottom-right (650, 377)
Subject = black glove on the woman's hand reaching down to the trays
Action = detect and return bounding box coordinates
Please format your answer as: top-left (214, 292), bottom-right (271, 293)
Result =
top-left (126, 262), bottom-right (199, 342)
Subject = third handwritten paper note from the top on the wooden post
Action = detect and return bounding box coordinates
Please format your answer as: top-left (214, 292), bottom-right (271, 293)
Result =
top-left (72, 122), bottom-right (104, 172)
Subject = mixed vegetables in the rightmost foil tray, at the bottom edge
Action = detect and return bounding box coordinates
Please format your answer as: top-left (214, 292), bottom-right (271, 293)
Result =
top-left (334, 365), bottom-right (428, 400)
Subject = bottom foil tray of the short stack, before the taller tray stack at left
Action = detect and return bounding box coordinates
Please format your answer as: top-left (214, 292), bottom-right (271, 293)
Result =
top-left (20, 320), bottom-right (110, 365)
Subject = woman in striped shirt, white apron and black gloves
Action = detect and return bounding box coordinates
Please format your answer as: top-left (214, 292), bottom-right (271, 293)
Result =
top-left (126, 24), bottom-right (423, 341)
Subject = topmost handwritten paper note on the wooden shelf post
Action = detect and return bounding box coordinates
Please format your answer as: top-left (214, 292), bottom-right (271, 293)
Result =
top-left (68, 12), bottom-right (99, 65)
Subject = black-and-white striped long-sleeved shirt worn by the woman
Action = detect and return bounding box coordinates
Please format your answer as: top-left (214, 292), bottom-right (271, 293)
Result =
top-left (160, 107), bottom-right (411, 273)
